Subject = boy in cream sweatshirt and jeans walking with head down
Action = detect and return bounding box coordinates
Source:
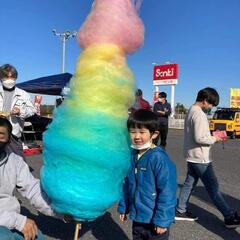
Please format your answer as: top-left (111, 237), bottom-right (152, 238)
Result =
top-left (175, 87), bottom-right (240, 228)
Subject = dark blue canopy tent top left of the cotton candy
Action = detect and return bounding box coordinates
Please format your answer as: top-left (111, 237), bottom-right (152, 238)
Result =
top-left (17, 73), bottom-right (72, 96)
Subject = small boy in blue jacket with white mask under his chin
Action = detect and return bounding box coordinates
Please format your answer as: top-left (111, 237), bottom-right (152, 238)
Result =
top-left (118, 109), bottom-right (177, 240)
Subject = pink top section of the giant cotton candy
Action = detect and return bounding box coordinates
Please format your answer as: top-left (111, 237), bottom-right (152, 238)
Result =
top-left (78, 0), bottom-right (144, 54)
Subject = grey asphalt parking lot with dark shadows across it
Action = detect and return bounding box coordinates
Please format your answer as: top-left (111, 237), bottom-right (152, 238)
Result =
top-left (21, 130), bottom-right (240, 240)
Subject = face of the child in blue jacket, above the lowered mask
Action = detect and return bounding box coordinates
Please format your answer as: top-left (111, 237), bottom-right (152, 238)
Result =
top-left (129, 127), bottom-right (158, 147)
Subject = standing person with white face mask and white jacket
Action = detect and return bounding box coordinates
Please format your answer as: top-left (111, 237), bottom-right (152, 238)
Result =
top-left (0, 64), bottom-right (36, 157)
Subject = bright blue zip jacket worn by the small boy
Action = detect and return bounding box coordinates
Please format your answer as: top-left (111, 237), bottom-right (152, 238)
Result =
top-left (118, 147), bottom-right (177, 227)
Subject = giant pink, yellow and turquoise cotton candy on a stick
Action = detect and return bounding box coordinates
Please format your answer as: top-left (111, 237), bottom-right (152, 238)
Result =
top-left (41, 0), bottom-right (144, 221)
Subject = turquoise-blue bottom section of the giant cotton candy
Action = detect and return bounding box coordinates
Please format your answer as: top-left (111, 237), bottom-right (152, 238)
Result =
top-left (41, 105), bottom-right (129, 221)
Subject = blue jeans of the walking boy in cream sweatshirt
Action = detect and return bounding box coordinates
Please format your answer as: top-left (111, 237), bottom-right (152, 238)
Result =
top-left (177, 162), bottom-right (233, 218)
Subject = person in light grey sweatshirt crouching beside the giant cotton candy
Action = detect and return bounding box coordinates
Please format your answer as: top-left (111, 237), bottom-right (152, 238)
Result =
top-left (0, 117), bottom-right (55, 240)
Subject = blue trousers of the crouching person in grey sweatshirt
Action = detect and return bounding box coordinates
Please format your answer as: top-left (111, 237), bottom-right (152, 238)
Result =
top-left (0, 226), bottom-right (45, 240)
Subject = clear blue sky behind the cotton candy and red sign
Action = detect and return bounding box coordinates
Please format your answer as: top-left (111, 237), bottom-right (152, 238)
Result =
top-left (0, 0), bottom-right (240, 106)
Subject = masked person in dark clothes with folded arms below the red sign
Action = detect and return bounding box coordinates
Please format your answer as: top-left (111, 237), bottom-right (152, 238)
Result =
top-left (153, 92), bottom-right (172, 149)
